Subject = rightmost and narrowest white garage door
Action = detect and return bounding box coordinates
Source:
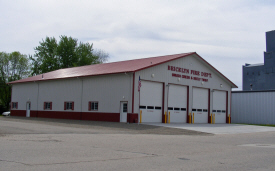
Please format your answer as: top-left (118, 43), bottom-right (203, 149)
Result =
top-left (212, 90), bottom-right (226, 123)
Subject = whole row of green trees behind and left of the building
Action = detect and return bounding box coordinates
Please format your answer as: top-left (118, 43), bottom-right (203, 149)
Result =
top-left (0, 36), bottom-right (109, 113)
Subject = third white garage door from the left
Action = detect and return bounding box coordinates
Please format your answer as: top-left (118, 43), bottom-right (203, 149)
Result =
top-left (192, 88), bottom-right (208, 123)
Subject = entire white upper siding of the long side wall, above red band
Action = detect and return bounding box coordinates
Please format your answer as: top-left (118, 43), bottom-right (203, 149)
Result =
top-left (12, 73), bottom-right (133, 113)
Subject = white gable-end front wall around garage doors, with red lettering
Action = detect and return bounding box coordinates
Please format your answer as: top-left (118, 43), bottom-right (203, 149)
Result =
top-left (134, 55), bottom-right (234, 114)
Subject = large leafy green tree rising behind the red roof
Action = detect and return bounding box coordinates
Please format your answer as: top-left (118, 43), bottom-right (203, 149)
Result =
top-left (30, 36), bottom-right (109, 75)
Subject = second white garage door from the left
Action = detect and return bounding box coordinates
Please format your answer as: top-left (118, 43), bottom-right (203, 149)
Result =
top-left (168, 84), bottom-right (187, 123)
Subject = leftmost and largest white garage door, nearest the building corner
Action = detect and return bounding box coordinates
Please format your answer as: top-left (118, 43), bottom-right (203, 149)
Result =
top-left (139, 81), bottom-right (163, 122)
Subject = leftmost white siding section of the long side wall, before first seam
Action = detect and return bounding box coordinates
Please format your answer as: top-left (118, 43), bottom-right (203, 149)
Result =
top-left (12, 83), bottom-right (38, 110)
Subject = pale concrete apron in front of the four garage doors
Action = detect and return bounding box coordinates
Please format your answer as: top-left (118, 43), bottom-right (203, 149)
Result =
top-left (143, 123), bottom-right (275, 134)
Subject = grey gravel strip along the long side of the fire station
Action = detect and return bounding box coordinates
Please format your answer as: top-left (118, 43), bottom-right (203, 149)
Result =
top-left (0, 116), bottom-right (213, 136)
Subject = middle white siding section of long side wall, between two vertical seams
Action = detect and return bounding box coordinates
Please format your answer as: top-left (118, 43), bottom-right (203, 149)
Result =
top-left (38, 78), bottom-right (82, 112)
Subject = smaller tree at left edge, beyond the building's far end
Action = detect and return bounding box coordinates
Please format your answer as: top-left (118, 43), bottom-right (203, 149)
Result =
top-left (0, 52), bottom-right (30, 110)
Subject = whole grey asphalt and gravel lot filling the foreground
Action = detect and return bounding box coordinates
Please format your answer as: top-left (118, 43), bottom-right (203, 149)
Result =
top-left (0, 117), bottom-right (275, 171)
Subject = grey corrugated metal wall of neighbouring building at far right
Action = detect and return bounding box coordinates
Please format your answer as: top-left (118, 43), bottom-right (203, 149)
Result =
top-left (234, 92), bottom-right (275, 125)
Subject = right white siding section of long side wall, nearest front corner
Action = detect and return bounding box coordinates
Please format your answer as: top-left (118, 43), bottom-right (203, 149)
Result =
top-left (82, 73), bottom-right (133, 113)
